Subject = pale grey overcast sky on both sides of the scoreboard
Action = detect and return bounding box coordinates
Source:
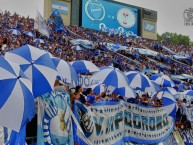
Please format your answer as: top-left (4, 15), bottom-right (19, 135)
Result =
top-left (0, 0), bottom-right (193, 40)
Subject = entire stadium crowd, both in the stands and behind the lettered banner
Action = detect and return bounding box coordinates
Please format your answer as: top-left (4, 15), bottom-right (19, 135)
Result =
top-left (0, 11), bottom-right (193, 137)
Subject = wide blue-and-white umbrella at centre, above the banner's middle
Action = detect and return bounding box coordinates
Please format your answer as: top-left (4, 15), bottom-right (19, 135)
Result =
top-left (91, 68), bottom-right (128, 88)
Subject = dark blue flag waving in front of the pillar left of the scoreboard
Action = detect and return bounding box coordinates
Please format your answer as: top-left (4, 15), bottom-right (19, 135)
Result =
top-left (51, 9), bottom-right (64, 32)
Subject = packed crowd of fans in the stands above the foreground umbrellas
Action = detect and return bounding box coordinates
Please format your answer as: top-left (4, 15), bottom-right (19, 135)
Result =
top-left (0, 11), bottom-right (192, 77)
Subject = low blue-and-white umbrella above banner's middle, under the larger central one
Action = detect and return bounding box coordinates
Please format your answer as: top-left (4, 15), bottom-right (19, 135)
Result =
top-left (113, 86), bottom-right (136, 99)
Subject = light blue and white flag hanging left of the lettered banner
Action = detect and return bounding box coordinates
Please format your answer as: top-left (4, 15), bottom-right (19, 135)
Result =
top-left (37, 92), bottom-right (74, 145)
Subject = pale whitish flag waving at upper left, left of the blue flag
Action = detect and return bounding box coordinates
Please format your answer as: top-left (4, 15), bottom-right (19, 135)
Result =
top-left (34, 10), bottom-right (50, 38)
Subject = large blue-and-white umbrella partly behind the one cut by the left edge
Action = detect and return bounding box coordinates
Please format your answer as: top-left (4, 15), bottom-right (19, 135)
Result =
top-left (5, 45), bottom-right (57, 97)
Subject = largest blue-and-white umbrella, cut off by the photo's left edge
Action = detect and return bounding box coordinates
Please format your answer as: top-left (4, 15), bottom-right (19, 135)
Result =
top-left (0, 57), bottom-right (35, 132)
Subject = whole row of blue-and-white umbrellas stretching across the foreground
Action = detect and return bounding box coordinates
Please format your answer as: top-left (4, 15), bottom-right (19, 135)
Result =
top-left (0, 42), bottom-right (193, 136)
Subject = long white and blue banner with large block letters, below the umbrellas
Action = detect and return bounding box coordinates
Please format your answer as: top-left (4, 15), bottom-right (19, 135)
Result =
top-left (74, 101), bottom-right (173, 145)
